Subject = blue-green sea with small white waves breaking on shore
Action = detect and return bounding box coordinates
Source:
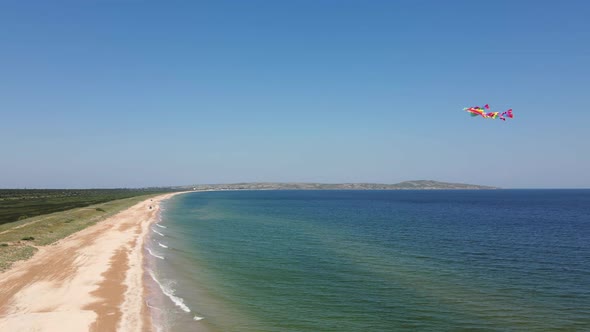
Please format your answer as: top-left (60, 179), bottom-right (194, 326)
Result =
top-left (145, 190), bottom-right (590, 332)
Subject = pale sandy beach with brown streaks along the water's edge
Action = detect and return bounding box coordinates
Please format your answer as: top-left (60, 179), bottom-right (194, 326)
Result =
top-left (0, 193), bottom-right (185, 331)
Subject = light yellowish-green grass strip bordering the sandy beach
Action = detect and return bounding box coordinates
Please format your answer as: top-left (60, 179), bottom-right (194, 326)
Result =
top-left (0, 193), bottom-right (157, 271)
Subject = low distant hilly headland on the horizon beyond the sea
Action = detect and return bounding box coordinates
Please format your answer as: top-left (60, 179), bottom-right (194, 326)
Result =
top-left (182, 180), bottom-right (498, 190)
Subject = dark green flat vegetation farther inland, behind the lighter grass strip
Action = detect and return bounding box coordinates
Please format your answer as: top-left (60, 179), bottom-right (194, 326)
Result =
top-left (0, 188), bottom-right (173, 225)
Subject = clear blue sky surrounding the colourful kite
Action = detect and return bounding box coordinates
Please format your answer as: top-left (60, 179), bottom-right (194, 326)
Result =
top-left (0, 0), bottom-right (590, 188)
